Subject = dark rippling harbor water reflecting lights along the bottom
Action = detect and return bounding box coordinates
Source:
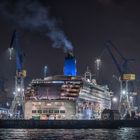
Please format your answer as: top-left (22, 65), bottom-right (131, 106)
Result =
top-left (0, 128), bottom-right (140, 140)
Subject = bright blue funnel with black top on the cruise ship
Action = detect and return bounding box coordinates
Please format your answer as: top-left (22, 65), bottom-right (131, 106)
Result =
top-left (64, 52), bottom-right (77, 76)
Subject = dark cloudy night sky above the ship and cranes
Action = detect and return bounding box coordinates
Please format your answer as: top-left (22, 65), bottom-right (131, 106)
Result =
top-left (0, 0), bottom-right (140, 101)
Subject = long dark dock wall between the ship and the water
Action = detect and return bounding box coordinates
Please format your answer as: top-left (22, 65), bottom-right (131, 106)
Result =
top-left (0, 120), bottom-right (140, 129)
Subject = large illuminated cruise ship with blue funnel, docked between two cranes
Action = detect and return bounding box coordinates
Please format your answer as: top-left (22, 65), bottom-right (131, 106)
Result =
top-left (24, 53), bottom-right (111, 120)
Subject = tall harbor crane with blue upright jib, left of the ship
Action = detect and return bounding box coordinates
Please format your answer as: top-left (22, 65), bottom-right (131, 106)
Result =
top-left (9, 31), bottom-right (26, 118)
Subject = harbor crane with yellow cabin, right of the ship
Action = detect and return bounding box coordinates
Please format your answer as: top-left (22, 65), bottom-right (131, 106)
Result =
top-left (97, 41), bottom-right (135, 118)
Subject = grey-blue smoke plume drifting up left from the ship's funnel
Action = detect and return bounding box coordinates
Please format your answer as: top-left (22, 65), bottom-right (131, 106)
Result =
top-left (0, 0), bottom-right (73, 51)
